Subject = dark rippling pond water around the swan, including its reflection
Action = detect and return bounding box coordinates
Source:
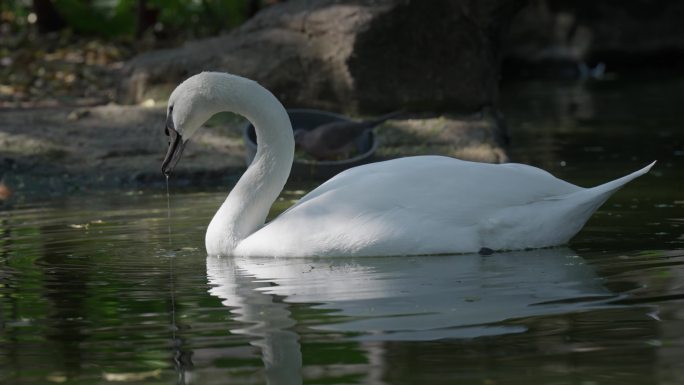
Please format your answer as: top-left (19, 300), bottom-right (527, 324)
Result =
top-left (0, 79), bottom-right (684, 385)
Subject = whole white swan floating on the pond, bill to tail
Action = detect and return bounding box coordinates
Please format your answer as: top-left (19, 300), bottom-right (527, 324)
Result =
top-left (162, 72), bottom-right (655, 257)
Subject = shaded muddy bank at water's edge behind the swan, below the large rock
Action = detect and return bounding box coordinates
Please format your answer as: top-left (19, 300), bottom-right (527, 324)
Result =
top-left (0, 104), bottom-right (507, 203)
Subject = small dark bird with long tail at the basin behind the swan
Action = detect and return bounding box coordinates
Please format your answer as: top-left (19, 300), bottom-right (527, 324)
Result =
top-left (294, 111), bottom-right (402, 160)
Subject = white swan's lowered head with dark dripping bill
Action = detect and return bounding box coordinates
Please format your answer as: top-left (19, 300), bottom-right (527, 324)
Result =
top-left (162, 72), bottom-right (230, 176)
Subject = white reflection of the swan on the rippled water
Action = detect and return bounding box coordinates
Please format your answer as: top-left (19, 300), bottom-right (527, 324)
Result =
top-left (207, 248), bottom-right (614, 384)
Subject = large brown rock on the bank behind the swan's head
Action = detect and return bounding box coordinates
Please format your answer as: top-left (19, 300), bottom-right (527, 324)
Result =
top-left (122, 0), bottom-right (525, 112)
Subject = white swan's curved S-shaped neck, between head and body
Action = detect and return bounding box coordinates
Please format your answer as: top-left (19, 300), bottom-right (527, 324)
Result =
top-left (205, 76), bottom-right (294, 255)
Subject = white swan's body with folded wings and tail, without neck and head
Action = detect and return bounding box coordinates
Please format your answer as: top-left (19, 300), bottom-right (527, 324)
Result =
top-left (235, 156), bottom-right (646, 256)
